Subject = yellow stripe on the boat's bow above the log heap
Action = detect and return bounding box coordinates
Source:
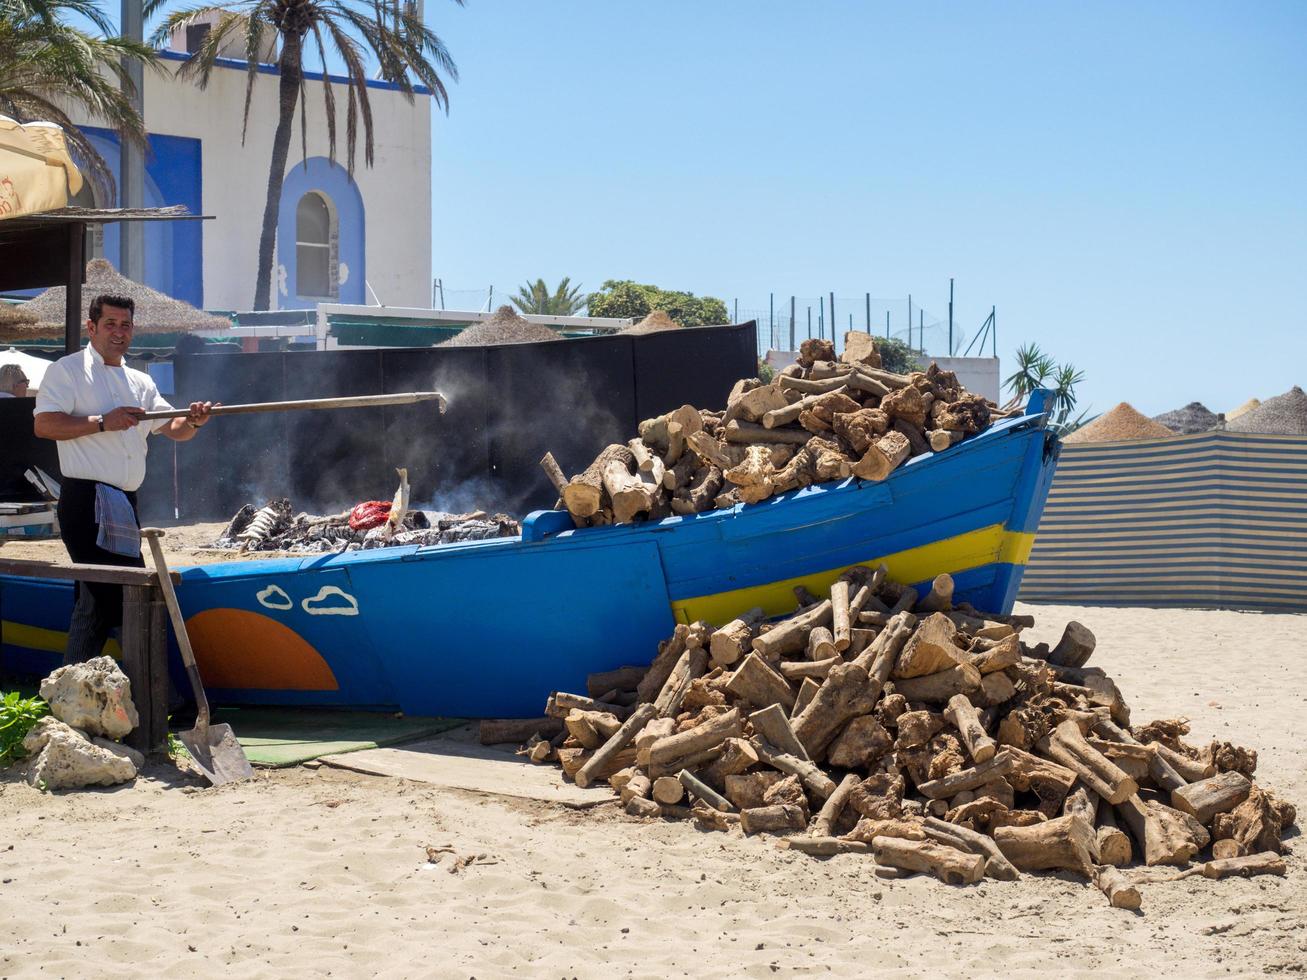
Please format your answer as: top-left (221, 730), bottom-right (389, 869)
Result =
top-left (672, 524), bottom-right (1035, 626)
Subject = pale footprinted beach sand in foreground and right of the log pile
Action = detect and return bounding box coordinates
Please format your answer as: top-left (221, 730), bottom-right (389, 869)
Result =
top-left (0, 606), bottom-right (1307, 979)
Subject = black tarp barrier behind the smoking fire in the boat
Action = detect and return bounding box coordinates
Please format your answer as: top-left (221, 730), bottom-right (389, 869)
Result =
top-left (28, 323), bottom-right (757, 521)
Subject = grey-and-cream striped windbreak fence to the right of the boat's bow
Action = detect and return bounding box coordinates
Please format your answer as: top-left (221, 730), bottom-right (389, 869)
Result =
top-left (1019, 431), bottom-right (1307, 610)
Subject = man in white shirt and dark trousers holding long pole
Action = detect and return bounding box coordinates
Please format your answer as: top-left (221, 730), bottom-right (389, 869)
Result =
top-left (34, 295), bottom-right (212, 664)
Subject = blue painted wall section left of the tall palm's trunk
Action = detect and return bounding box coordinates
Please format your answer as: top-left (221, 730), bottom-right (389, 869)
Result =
top-left (82, 127), bottom-right (204, 308)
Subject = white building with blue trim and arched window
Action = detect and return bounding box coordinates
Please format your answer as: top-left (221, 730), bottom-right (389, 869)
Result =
top-left (66, 26), bottom-right (431, 310)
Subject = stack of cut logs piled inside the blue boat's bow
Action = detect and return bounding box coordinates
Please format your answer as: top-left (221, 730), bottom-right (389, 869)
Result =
top-left (541, 332), bottom-right (997, 527)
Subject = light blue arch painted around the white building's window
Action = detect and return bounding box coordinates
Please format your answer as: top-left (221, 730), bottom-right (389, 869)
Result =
top-left (277, 157), bottom-right (367, 310)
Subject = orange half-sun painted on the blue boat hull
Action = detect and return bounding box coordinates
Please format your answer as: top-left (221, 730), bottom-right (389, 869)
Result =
top-left (186, 609), bottom-right (340, 691)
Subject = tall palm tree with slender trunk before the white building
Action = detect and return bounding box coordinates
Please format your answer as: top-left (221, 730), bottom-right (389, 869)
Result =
top-left (145, 0), bottom-right (463, 310)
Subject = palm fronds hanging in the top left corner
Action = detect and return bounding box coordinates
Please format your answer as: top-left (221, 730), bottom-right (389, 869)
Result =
top-left (0, 0), bottom-right (156, 201)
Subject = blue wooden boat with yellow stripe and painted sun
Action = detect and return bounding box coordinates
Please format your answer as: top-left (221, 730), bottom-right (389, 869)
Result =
top-left (0, 392), bottom-right (1057, 717)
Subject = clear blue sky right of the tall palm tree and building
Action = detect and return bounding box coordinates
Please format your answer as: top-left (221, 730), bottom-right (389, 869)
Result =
top-left (426, 0), bottom-right (1307, 414)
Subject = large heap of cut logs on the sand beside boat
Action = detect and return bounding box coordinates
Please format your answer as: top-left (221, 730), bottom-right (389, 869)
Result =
top-left (501, 566), bottom-right (1295, 908)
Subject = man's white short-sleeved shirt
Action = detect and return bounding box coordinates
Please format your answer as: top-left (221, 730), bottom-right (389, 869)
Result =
top-left (34, 344), bottom-right (173, 499)
